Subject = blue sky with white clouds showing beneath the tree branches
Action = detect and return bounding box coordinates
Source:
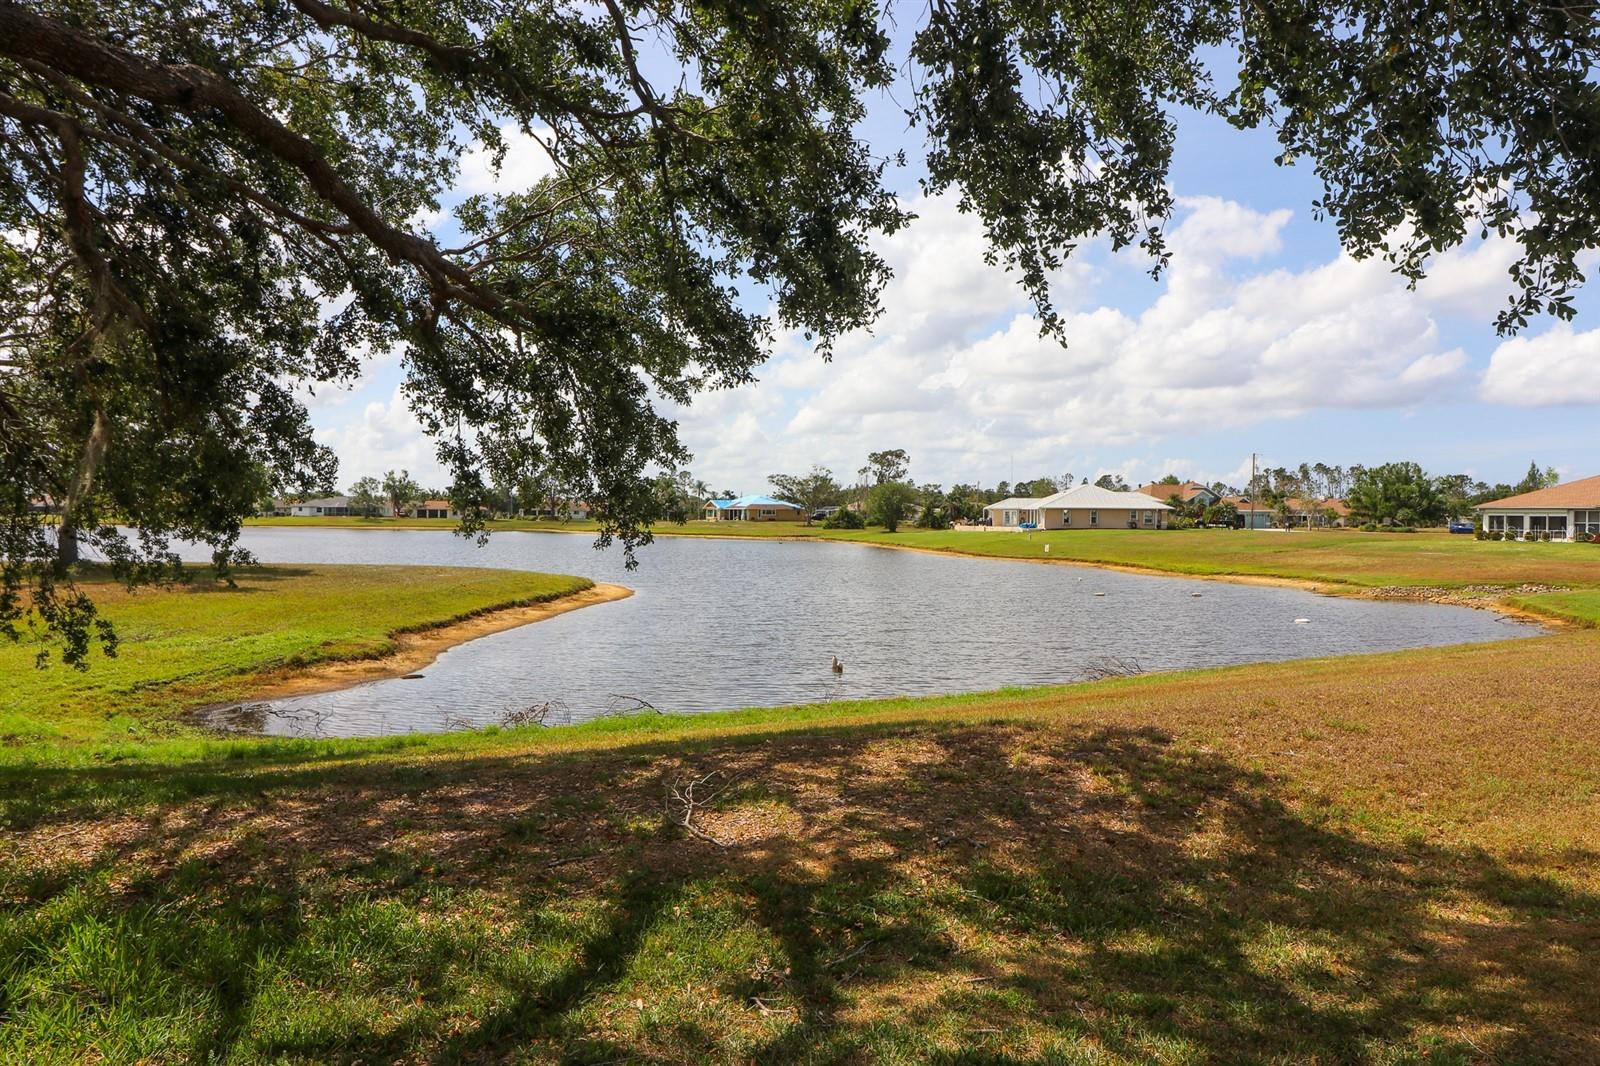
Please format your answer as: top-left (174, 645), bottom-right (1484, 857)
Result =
top-left (310, 54), bottom-right (1600, 493)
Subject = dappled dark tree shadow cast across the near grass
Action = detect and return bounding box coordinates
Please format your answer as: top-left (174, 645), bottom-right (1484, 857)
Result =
top-left (0, 723), bottom-right (1600, 1063)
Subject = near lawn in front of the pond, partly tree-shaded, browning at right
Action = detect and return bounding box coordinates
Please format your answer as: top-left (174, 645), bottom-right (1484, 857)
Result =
top-left (0, 631), bottom-right (1600, 1063)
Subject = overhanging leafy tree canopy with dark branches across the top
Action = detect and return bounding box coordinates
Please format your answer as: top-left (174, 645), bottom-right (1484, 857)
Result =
top-left (0, 0), bottom-right (1600, 659)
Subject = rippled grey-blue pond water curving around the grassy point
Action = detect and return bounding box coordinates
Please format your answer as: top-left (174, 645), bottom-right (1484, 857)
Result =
top-left (184, 528), bottom-right (1541, 736)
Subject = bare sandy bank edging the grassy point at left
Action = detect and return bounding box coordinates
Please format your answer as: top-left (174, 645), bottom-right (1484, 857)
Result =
top-left (195, 581), bottom-right (634, 710)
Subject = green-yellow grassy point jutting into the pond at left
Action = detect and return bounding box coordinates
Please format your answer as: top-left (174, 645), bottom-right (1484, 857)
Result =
top-left (0, 565), bottom-right (592, 747)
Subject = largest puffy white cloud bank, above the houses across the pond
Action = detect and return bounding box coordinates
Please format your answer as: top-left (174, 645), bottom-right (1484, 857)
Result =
top-left (683, 197), bottom-right (1472, 483)
